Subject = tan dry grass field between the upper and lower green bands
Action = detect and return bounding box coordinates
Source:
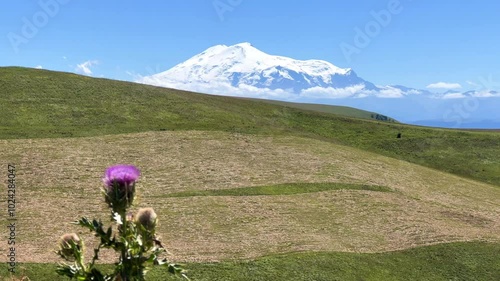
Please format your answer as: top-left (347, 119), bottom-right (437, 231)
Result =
top-left (0, 132), bottom-right (500, 262)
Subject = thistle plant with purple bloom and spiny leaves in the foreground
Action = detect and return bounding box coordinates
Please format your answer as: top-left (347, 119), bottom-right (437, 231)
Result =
top-left (56, 165), bottom-right (189, 281)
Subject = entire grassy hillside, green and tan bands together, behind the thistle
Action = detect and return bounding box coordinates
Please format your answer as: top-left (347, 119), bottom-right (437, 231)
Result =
top-left (0, 67), bottom-right (500, 281)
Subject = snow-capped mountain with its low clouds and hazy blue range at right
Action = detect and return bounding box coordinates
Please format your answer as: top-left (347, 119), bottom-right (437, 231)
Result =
top-left (136, 43), bottom-right (500, 127)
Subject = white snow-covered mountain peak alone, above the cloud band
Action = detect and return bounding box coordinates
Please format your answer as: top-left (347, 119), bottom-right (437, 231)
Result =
top-left (143, 42), bottom-right (356, 92)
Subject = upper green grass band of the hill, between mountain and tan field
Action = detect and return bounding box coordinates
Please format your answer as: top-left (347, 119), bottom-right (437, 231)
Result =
top-left (0, 67), bottom-right (500, 186)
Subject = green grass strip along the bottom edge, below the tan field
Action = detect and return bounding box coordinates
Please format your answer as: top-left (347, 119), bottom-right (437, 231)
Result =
top-left (0, 242), bottom-right (500, 281)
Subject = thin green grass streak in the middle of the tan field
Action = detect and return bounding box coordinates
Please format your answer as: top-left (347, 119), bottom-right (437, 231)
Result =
top-left (165, 183), bottom-right (392, 197)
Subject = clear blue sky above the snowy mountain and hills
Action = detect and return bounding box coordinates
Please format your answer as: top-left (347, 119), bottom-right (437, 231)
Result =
top-left (0, 0), bottom-right (500, 90)
